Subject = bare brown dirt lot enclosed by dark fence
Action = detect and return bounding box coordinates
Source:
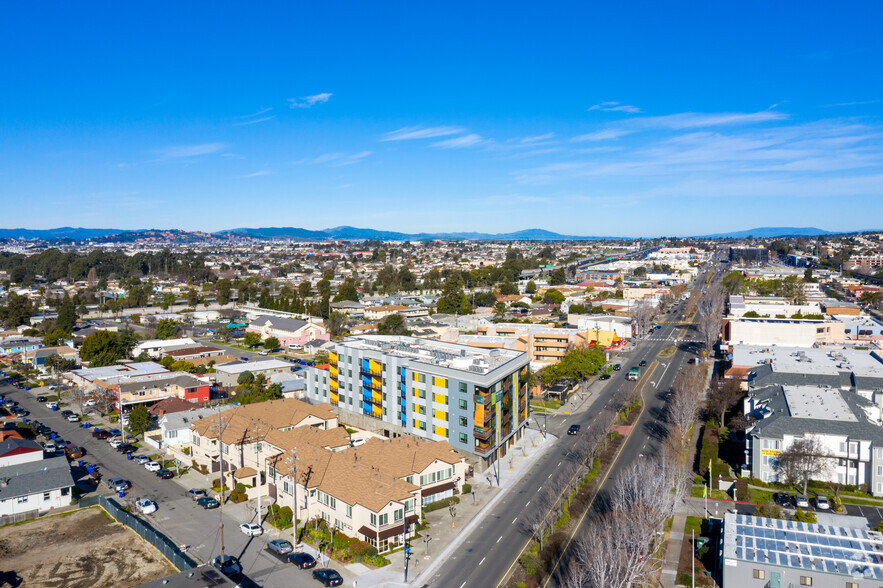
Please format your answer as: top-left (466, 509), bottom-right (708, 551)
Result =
top-left (0, 507), bottom-right (177, 588)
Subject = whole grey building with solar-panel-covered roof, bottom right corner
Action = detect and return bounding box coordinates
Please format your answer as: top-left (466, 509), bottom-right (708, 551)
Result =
top-left (721, 513), bottom-right (883, 588)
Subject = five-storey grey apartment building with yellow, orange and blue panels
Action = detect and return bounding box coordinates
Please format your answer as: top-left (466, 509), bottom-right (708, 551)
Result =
top-left (305, 335), bottom-right (530, 465)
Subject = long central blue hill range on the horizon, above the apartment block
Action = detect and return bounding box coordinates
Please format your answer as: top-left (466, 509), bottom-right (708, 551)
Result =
top-left (221, 226), bottom-right (619, 241)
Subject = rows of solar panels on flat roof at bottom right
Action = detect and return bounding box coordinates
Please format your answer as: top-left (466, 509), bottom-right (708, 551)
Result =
top-left (724, 513), bottom-right (883, 581)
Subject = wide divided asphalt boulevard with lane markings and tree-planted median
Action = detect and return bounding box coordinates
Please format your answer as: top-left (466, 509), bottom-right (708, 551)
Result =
top-left (428, 303), bottom-right (699, 588)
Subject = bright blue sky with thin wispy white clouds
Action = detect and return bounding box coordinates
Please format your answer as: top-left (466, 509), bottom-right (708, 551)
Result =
top-left (0, 1), bottom-right (883, 236)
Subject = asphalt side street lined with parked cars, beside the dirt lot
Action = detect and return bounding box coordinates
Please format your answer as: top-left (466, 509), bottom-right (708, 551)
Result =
top-left (0, 379), bottom-right (322, 587)
